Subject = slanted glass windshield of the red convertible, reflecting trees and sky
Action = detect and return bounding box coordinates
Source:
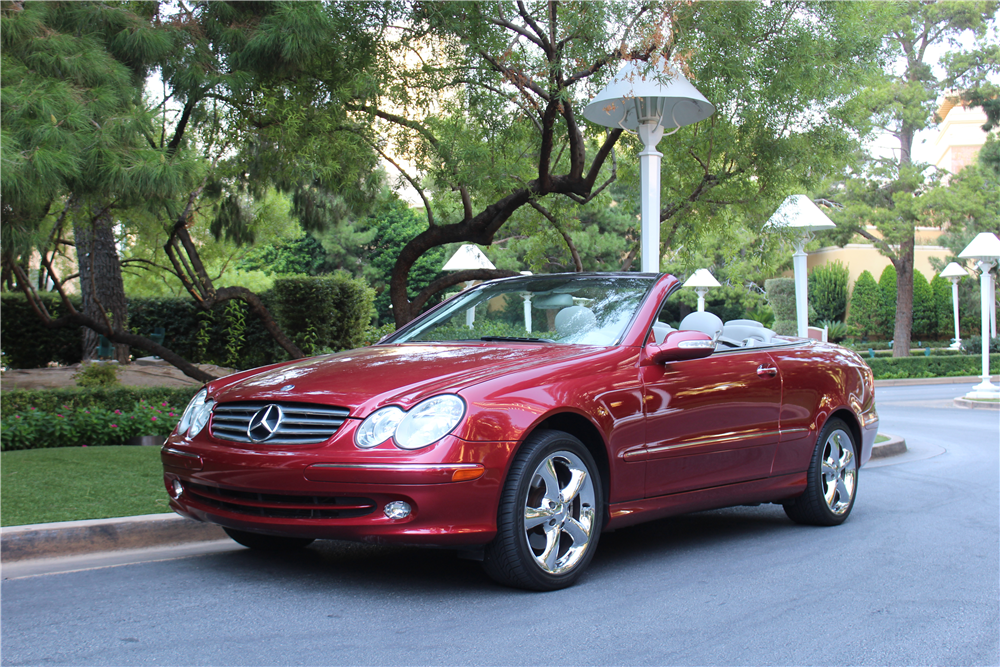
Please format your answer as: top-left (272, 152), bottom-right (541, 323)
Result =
top-left (386, 275), bottom-right (654, 345)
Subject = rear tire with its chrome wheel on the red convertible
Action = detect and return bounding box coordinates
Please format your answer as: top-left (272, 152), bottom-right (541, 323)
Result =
top-left (784, 419), bottom-right (858, 526)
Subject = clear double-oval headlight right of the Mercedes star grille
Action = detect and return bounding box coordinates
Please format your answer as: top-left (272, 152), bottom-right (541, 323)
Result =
top-left (354, 394), bottom-right (465, 449)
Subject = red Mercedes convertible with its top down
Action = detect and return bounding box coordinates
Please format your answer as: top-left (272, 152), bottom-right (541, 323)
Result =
top-left (162, 273), bottom-right (878, 590)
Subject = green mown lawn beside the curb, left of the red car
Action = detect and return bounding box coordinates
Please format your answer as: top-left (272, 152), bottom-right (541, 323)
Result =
top-left (0, 447), bottom-right (170, 526)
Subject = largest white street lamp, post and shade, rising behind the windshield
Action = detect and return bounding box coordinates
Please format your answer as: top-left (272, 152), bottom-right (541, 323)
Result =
top-left (583, 62), bottom-right (715, 273)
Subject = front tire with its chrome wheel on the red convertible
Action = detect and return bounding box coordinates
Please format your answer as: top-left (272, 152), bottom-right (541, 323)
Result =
top-left (483, 431), bottom-right (604, 591)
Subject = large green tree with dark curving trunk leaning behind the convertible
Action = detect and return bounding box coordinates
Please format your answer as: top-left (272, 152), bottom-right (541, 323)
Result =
top-left (358, 2), bottom-right (884, 323)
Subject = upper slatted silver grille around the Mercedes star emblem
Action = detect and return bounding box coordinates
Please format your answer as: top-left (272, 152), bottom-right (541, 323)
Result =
top-left (212, 401), bottom-right (350, 445)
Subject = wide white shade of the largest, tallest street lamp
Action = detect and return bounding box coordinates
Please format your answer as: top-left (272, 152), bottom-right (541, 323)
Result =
top-left (583, 62), bottom-right (715, 132)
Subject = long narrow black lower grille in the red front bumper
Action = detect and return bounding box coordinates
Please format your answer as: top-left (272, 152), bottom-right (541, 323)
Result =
top-left (184, 482), bottom-right (375, 519)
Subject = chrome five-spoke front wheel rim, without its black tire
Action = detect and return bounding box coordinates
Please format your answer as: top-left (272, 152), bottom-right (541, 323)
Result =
top-left (524, 451), bottom-right (596, 574)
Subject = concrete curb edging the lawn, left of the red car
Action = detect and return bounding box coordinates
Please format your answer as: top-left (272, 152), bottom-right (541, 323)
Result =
top-left (0, 514), bottom-right (226, 562)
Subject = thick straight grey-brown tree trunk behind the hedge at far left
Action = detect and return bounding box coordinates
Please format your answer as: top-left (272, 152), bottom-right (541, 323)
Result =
top-left (73, 208), bottom-right (129, 364)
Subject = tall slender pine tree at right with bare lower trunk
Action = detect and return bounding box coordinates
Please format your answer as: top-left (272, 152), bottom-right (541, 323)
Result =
top-left (834, 1), bottom-right (998, 357)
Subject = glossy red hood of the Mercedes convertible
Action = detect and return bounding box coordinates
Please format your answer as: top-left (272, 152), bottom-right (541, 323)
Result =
top-left (209, 344), bottom-right (604, 417)
